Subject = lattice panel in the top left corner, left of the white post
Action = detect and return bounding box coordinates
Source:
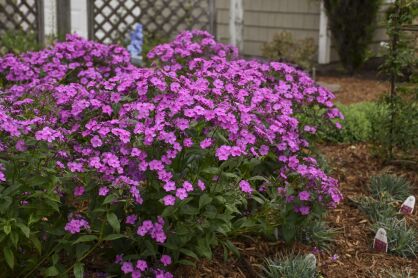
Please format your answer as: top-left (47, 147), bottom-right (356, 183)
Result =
top-left (0, 0), bottom-right (44, 42)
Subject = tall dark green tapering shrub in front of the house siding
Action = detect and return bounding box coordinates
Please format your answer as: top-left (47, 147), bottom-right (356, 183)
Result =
top-left (324, 0), bottom-right (382, 73)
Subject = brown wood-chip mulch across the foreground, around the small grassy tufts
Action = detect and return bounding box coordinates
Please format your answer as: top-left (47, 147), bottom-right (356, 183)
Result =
top-left (176, 144), bottom-right (418, 278)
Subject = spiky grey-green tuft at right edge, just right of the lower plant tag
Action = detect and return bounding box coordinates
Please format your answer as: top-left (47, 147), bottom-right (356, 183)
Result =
top-left (373, 217), bottom-right (418, 258)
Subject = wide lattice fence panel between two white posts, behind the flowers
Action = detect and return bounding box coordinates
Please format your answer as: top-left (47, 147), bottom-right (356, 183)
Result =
top-left (87, 0), bottom-right (216, 43)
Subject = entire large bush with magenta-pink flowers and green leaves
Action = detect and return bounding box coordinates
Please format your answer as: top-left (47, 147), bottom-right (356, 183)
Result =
top-left (0, 31), bottom-right (342, 277)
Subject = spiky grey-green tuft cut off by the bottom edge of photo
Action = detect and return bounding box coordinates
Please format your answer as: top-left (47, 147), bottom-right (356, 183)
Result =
top-left (263, 255), bottom-right (317, 278)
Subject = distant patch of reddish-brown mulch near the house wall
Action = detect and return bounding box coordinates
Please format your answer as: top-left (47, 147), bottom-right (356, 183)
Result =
top-left (318, 76), bottom-right (389, 104)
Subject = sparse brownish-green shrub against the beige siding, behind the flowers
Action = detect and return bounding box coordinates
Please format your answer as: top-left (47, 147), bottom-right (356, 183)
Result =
top-left (262, 32), bottom-right (316, 70)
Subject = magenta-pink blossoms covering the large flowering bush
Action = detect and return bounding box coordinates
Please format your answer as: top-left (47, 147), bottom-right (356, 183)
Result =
top-left (0, 31), bottom-right (342, 277)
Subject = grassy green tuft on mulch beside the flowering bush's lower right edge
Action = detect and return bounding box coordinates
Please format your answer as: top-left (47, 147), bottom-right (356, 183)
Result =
top-left (298, 220), bottom-right (338, 251)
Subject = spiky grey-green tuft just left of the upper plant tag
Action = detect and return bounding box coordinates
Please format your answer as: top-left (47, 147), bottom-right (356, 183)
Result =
top-left (357, 196), bottom-right (396, 222)
